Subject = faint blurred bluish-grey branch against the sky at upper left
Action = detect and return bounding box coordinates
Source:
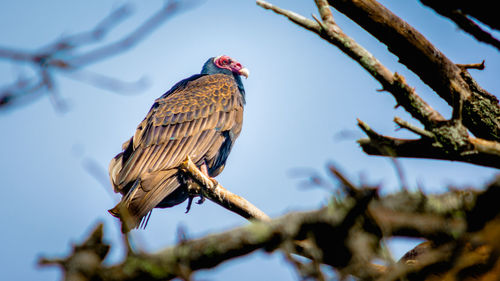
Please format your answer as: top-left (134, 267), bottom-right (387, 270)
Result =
top-left (0, 0), bottom-right (190, 110)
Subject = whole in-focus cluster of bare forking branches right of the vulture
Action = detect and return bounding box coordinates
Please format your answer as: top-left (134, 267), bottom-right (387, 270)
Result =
top-left (257, 0), bottom-right (500, 167)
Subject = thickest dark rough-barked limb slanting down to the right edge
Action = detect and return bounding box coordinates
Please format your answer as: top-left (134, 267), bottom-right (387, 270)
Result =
top-left (328, 0), bottom-right (500, 141)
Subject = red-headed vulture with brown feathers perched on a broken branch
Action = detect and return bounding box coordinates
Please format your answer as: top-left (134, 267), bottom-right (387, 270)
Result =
top-left (109, 56), bottom-right (248, 230)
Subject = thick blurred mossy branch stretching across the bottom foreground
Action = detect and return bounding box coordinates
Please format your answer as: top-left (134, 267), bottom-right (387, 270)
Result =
top-left (39, 167), bottom-right (500, 280)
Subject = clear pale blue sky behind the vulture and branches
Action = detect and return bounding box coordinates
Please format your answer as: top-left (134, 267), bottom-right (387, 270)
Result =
top-left (0, 0), bottom-right (500, 281)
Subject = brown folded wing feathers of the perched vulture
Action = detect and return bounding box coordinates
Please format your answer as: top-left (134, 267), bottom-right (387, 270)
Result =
top-left (110, 74), bottom-right (243, 224)
